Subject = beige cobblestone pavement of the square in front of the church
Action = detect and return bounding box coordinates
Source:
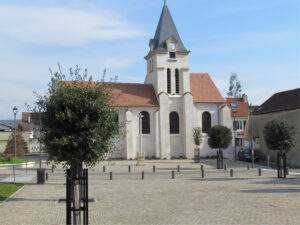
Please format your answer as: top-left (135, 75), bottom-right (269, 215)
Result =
top-left (0, 160), bottom-right (300, 225)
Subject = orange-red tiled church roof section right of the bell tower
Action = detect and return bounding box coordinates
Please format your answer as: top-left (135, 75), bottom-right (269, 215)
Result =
top-left (190, 73), bottom-right (225, 103)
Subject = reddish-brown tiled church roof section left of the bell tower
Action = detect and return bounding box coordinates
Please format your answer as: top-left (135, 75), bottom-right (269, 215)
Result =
top-left (111, 83), bottom-right (158, 107)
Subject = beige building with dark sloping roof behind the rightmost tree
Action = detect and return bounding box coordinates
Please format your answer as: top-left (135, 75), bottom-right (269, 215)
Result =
top-left (253, 88), bottom-right (300, 167)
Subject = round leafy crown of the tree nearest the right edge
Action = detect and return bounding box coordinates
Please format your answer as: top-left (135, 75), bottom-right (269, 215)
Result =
top-left (264, 120), bottom-right (295, 152)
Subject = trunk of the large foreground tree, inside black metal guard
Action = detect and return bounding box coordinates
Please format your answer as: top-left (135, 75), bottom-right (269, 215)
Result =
top-left (71, 163), bottom-right (82, 225)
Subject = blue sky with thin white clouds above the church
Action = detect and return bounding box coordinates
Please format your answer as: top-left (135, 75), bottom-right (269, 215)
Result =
top-left (0, 0), bottom-right (300, 119)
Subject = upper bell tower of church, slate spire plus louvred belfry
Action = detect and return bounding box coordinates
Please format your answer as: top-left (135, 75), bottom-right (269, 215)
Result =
top-left (145, 2), bottom-right (190, 96)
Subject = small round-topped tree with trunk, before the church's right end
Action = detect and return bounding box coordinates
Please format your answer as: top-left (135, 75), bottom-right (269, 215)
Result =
top-left (208, 125), bottom-right (232, 169)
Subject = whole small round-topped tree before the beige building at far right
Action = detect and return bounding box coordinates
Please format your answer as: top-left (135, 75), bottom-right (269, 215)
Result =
top-left (264, 120), bottom-right (295, 178)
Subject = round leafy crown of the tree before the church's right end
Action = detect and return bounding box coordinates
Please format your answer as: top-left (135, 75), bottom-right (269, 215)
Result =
top-left (208, 125), bottom-right (232, 149)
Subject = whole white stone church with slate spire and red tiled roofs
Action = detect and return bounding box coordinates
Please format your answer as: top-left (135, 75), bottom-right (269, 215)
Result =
top-left (112, 3), bottom-right (232, 159)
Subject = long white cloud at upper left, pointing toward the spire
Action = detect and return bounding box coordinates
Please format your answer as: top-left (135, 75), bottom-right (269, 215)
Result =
top-left (0, 5), bottom-right (143, 45)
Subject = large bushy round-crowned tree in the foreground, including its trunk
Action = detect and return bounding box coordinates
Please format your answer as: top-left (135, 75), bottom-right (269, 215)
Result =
top-left (36, 66), bottom-right (118, 225)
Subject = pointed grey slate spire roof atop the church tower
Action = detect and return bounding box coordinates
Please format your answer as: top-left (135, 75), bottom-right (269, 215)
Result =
top-left (150, 0), bottom-right (188, 52)
